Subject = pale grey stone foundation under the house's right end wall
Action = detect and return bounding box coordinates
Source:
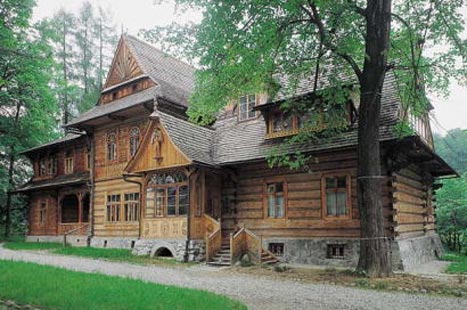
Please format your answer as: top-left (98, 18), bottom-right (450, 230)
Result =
top-left (392, 233), bottom-right (443, 271)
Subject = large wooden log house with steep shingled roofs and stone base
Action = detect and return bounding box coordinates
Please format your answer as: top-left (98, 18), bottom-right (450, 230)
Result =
top-left (18, 35), bottom-right (456, 268)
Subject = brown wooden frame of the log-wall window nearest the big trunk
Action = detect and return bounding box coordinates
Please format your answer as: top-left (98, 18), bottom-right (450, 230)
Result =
top-left (321, 172), bottom-right (352, 220)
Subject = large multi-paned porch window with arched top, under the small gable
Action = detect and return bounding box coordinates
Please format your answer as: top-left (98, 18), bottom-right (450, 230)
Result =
top-left (146, 172), bottom-right (189, 217)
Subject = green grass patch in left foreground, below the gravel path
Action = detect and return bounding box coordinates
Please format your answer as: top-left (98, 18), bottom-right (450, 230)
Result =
top-left (0, 260), bottom-right (246, 310)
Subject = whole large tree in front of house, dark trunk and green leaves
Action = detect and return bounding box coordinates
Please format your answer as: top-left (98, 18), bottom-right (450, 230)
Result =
top-left (146, 0), bottom-right (467, 276)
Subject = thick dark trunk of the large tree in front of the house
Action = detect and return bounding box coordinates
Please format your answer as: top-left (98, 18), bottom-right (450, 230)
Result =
top-left (357, 0), bottom-right (392, 277)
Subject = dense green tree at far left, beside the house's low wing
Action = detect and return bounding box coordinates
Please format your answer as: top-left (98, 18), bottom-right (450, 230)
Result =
top-left (0, 0), bottom-right (60, 237)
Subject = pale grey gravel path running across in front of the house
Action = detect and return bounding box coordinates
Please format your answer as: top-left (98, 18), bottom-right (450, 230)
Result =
top-left (0, 247), bottom-right (467, 310)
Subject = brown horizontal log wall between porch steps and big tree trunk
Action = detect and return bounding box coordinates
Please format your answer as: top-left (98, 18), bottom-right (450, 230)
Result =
top-left (222, 151), bottom-right (393, 238)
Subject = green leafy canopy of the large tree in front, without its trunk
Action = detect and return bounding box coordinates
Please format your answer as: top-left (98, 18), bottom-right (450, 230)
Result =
top-left (143, 0), bottom-right (467, 123)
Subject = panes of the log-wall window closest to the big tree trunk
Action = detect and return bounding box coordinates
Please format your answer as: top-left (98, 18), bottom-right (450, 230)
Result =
top-left (322, 176), bottom-right (350, 218)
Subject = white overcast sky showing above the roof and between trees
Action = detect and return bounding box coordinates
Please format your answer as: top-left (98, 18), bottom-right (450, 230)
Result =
top-left (33, 0), bottom-right (467, 135)
